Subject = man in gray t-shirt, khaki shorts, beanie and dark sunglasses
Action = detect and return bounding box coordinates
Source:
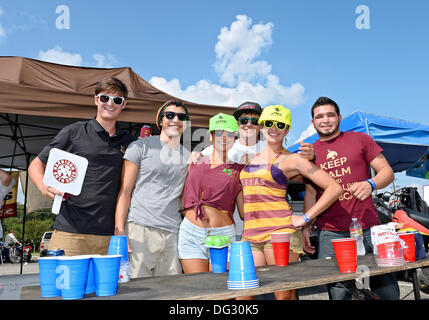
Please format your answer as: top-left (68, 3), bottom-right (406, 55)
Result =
top-left (115, 100), bottom-right (189, 278)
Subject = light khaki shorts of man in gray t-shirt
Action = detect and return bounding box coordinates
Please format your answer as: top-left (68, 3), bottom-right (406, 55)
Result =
top-left (125, 223), bottom-right (182, 278)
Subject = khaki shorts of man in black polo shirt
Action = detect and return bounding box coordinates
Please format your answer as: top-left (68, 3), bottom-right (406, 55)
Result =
top-left (48, 230), bottom-right (110, 256)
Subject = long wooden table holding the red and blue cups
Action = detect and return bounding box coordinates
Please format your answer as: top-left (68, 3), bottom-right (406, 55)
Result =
top-left (21, 254), bottom-right (429, 300)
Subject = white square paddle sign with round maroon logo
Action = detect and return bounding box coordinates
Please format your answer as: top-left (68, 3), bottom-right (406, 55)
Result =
top-left (43, 148), bottom-right (88, 214)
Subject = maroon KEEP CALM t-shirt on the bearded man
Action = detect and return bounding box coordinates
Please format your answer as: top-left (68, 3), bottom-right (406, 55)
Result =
top-left (313, 132), bottom-right (383, 231)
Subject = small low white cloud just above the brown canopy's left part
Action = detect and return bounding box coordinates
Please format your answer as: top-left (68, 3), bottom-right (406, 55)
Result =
top-left (38, 46), bottom-right (117, 68)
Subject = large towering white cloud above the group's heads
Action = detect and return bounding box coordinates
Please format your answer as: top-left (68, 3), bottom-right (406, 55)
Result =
top-left (149, 15), bottom-right (305, 107)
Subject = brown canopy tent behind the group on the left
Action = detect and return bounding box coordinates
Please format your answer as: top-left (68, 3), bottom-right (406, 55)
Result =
top-left (0, 57), bottom-right (232, 170)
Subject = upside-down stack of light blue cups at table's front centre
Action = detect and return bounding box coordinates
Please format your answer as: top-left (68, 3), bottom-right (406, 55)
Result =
top-left (228, 241), bottom-right (259, 290)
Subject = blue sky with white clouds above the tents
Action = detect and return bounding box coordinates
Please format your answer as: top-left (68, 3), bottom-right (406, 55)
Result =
top-left (0, 0), bottom-right (429, 198)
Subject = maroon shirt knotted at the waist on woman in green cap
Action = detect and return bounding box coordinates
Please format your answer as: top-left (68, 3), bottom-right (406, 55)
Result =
top-left (183, 157), bottom-right (244, 220)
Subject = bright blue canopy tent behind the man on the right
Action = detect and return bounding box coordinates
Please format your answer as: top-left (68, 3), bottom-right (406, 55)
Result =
top-left (288, 111), bottom-right (429, 172)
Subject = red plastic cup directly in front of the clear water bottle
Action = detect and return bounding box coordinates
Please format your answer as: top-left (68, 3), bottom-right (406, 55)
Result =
top-left (331, 238), bottom-right (357, 273)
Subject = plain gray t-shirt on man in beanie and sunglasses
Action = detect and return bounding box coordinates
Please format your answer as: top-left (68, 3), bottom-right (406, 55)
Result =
top-left (124, 136), bottom-right (189, 233)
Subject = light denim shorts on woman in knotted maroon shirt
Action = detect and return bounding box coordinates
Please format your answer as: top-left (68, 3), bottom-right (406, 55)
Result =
top-left (178, 217), bottom-right (235, 261)
